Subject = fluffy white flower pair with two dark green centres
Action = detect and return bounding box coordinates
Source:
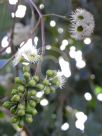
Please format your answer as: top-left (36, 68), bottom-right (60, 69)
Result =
top-left (70, 8), bottom-right (95, 40)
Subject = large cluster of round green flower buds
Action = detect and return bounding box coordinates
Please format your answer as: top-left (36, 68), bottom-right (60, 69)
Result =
top-left (3, 66), bottom-right (64, 127)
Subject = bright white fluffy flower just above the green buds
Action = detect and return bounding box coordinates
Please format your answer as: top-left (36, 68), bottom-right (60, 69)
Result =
top-left (13, 39), bottom-right (40, 66)
